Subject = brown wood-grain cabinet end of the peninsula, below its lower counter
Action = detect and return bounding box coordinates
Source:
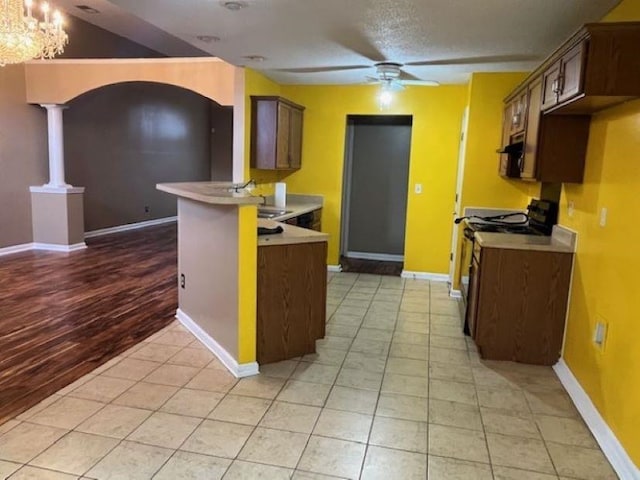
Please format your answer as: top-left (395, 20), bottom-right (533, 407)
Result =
top-left (256, 242), bottom-right (327, 364)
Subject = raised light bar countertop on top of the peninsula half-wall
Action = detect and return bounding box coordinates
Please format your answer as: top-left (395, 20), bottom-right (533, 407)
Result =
top-left (156, 182), bottom-right (264, 205)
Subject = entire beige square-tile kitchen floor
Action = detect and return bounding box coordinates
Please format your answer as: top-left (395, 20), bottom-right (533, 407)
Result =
top-left (0, 274), bottom-right (617, 480)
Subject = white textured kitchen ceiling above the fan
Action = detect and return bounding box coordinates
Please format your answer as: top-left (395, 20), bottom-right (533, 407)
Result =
top-left (57, 0), bottom-right (619, 84)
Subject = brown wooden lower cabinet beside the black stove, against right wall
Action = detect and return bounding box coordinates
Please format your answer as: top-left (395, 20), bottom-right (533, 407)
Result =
top-left (468, 248), bottom-right (573, 365)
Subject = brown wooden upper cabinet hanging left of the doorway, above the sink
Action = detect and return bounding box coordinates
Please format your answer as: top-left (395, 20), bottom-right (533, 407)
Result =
top-left (251, 96), bottom-right (304, 170)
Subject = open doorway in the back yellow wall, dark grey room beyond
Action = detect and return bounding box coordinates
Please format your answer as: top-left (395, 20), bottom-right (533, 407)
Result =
top-left (341, 115), bottom-right (413, 275)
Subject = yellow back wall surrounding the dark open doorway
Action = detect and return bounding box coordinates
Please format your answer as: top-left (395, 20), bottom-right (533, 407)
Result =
top-left (281, 85), bottom-right (466, 273)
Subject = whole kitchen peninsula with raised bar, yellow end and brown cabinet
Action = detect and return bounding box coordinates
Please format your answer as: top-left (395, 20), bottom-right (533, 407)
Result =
top-left (157, 182), bottom-right (328, 377)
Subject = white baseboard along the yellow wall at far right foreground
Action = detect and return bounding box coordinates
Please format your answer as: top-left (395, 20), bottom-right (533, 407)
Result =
top-left (553, 358), bottom-right (640, 480)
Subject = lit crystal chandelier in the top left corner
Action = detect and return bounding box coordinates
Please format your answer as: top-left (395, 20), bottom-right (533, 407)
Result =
top-left (0, 0), bottom-right (69, 66)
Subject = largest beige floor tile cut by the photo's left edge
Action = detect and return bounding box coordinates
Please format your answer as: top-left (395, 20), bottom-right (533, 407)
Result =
top-left (0, 423), bottom-right (67, 463)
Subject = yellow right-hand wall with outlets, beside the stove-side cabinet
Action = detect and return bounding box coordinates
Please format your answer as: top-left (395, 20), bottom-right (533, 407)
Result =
top-left (560, 0), bottom-right (640, 467)
